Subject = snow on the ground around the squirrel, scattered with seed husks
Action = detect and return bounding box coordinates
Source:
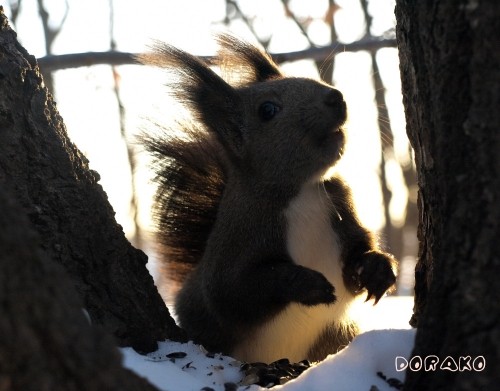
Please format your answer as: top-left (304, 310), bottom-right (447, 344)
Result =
top-left (122, 297), bottom-right (415, 391)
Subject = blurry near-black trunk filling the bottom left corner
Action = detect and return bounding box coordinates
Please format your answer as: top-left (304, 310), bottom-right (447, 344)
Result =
top-left (0, 183), bottom-right (156, 391)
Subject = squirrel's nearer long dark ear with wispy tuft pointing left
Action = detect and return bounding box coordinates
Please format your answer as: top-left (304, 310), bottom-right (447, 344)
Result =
top-left (139, 42), bottom-right (243, 158)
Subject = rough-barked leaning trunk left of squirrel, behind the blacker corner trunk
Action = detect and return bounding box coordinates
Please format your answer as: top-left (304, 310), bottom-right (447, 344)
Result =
top-left (0, 7), bottom-right (181, 358)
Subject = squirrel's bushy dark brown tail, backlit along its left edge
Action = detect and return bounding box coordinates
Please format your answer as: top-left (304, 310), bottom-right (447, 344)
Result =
top-left (142, 126), bottom-right (226, 282)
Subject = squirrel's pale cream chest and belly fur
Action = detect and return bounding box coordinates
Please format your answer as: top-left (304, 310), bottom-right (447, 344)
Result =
top-left (233, 184), bottom-right (354, 362)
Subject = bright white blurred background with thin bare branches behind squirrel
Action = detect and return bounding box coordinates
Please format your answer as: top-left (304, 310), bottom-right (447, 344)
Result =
top-left (2, 0), bottom-right (418, 302)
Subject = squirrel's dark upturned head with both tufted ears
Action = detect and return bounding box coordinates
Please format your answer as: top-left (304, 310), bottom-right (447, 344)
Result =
top-left (146, 35), bottom-right (346, 189)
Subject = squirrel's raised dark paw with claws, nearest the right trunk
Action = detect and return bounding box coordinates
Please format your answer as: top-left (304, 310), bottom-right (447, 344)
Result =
top-left (353, 251), bottom-right (396, 304)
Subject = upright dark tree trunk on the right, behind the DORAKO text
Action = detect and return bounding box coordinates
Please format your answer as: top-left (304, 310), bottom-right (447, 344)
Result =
top-left (396, 0), bottom-right (500, 390)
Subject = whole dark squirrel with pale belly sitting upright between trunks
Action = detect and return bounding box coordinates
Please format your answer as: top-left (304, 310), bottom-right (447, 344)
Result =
top-left (141, 34), bottom-right (396, 363)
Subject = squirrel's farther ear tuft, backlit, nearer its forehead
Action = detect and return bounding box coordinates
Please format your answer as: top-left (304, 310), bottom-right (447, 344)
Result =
top-left (217, 34), bottom-right (283, 84)
